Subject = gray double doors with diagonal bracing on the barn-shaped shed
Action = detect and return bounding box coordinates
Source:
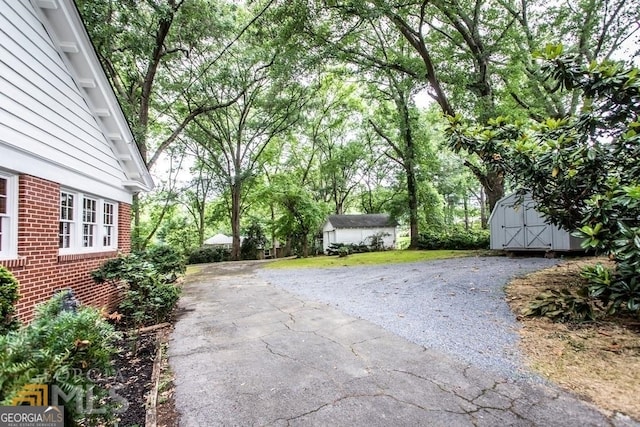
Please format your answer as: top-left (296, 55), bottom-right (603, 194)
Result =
top-left (501, 200), bottom-right (552, 249)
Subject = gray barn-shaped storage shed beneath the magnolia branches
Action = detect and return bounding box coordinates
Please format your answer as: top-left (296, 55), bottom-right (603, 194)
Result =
top-left (489, 194), bottom-right (583, 251)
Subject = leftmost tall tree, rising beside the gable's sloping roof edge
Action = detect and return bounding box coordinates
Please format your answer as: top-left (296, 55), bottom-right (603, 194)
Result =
top-left (77, 0), bottom-right (250, 249)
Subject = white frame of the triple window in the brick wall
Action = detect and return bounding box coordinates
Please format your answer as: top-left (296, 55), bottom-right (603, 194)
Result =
top-left (58, 188), bottom-right (118, 255)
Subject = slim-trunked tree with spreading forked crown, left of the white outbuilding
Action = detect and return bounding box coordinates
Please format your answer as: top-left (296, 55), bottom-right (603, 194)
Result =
top-left (188, 45), bottom-right (306, 260)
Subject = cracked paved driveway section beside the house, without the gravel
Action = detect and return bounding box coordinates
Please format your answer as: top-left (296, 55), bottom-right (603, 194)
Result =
top-left (169, 262), bottom-right (638, 427)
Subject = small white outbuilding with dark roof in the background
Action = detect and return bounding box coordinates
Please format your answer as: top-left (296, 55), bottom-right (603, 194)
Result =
top-left (322, 214), bottom-right (397, 252)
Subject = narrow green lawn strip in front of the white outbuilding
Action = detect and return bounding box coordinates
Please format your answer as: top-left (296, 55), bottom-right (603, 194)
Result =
top-left (264, 250), bottom-right (490, 268)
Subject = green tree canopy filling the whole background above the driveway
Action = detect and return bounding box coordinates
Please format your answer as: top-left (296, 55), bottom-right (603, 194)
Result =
top-left (77, 0), bottom-right (640, 270)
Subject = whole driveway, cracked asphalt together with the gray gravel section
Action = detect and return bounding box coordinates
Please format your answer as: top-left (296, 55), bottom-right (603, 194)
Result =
top-left (169, 260), bottom-right (638, 427)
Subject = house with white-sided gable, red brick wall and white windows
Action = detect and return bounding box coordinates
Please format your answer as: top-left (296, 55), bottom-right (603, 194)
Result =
top-left (0, 0), bottom-right (153, 321)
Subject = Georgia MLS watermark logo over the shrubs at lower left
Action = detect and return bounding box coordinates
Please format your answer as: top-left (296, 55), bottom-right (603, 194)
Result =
top-left (0, 370), bottom-right (129, 427)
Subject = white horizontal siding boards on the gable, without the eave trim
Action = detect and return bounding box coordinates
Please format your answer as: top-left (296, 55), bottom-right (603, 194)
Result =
top-left (0, 0), bottom-right (130, 201)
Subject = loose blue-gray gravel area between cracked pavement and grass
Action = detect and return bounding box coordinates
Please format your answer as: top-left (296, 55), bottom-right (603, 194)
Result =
top-left (258, 257), bottom-right (559, 380)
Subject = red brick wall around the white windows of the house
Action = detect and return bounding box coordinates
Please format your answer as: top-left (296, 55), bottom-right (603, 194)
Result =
top-left (0, 175), bottom-right (131, 322)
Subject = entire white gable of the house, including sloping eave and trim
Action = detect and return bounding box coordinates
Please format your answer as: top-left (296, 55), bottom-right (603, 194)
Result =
top-left (0, 0), bottom-right (153, 203)
